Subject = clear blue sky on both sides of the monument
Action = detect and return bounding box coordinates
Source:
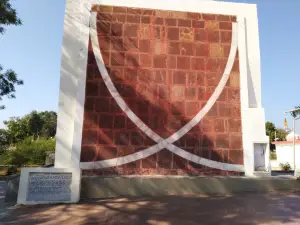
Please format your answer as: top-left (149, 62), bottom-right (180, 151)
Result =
top-left (0, 0), bottom-right (300, 132)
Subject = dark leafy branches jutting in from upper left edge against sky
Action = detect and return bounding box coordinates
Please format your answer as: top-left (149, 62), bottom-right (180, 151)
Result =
top-left (0, 0), bottom-right (23, 109)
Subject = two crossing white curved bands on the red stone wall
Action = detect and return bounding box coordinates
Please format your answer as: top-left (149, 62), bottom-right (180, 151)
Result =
top-left (80, 13), bottom-right (244, 172)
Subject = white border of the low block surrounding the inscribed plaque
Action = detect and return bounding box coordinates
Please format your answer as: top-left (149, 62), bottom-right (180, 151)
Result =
top-left (17, 168), bottom-right (81, 205)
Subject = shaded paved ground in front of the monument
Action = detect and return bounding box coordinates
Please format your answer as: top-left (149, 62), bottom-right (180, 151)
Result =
top-left (0, 193), bottom-right (300, 225)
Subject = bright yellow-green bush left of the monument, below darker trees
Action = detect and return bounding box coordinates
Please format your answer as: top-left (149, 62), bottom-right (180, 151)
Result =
top-left (5, 138), bottom-right (55, 167)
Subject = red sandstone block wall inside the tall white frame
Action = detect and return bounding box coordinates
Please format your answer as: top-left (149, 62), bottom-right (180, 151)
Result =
top-left (81, 6), bottom-right (243, 175)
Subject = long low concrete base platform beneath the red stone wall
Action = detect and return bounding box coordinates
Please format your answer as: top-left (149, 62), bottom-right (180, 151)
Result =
top-left (81, 176), bottom-right (300, 199)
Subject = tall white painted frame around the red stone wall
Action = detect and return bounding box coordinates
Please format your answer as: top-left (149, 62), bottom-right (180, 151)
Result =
top-left (55, 0), bottom-right (265, 176)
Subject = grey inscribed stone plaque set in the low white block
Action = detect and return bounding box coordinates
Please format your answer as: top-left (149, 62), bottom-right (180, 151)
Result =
top-left (27, 172), bottom-right (72, 202)
